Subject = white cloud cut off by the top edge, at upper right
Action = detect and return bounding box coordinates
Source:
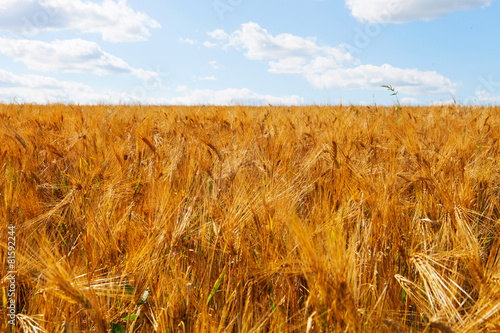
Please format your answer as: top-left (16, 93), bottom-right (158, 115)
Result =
top-left (346, 0), bottom-right (493, 23)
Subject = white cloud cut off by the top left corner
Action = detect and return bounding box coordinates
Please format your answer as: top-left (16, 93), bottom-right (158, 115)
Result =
top-left (0, 0), bottom-right (160, 42)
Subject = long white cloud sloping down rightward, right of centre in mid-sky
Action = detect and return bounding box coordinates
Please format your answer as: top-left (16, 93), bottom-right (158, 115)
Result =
top-left (208, 22), bottom-right (456, 95)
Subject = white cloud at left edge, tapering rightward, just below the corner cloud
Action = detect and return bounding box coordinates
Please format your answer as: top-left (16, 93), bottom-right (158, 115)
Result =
top-left (0, 38), bottom-right (157, 80)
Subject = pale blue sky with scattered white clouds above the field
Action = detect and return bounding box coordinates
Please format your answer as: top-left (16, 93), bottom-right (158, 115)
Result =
top-left (0, 0), bottom-right (500, 105)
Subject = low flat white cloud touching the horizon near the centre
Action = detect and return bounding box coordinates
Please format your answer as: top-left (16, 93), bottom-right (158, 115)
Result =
top-left (167, 86), bottom-right (304, 105)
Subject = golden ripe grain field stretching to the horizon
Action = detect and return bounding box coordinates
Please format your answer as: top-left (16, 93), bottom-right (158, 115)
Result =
top-left (0, 104), bottom-right (500, 333)
